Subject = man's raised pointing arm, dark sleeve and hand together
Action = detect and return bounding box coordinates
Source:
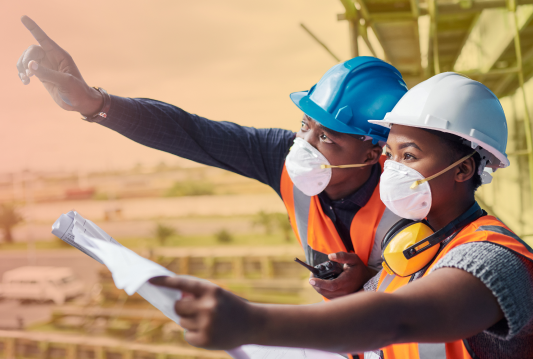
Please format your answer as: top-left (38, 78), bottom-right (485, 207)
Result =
top-left (17, 16), bottom-right (294, 194)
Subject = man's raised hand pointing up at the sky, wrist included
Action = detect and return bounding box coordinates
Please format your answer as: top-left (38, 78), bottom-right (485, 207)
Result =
top-left (17, 16), bottom-right (103, 115)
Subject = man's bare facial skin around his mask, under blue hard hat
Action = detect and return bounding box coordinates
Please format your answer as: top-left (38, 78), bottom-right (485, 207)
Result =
top-left (296, 115), bottom-right (381, 189)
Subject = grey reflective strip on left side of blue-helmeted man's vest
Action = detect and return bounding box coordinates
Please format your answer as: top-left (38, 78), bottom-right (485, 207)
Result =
top-left (292, 186), bottom-right (328, 266)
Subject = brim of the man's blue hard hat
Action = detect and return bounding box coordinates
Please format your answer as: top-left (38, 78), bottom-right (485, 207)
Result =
top-left (290, 91), bottom-right (387, 141)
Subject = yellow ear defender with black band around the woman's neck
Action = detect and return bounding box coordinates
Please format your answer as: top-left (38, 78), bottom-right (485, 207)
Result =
top-left (381, 202), bottom-right (487, 277)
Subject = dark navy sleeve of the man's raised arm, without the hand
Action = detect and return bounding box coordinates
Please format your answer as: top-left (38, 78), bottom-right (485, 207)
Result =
top-left (100, 96), bottom-right (294, 194)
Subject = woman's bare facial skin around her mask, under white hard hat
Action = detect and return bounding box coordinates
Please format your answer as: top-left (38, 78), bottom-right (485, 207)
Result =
top-left (385, 125), bottom-right (459, 217)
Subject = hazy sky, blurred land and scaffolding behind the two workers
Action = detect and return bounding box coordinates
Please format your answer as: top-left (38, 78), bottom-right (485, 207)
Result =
top-left (0, 0), bottom-right (533, 359)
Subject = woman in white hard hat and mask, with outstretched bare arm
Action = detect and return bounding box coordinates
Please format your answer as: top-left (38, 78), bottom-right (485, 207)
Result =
top-left (152, 73), bottom-right (533, 359)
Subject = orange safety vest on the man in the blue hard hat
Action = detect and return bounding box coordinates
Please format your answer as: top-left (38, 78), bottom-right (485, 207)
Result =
top-left (281, 156), bottom-right (399, 266)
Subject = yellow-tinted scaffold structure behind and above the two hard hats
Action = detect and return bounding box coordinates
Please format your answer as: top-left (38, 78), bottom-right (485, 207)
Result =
top-left (306, 0), bottom-right (533, 237)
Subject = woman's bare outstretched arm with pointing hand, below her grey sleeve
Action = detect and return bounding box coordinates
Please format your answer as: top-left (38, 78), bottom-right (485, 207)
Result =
top-left (149, 268), bottom-right (503, 353)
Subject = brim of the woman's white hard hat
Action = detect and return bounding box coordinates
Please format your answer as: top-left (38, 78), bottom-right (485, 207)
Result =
top-left (368, 117), bottom-right (510, 168)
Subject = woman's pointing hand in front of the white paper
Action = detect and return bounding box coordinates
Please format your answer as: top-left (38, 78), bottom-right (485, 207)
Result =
top-left (150, 277), bottom-right (252, 349)
